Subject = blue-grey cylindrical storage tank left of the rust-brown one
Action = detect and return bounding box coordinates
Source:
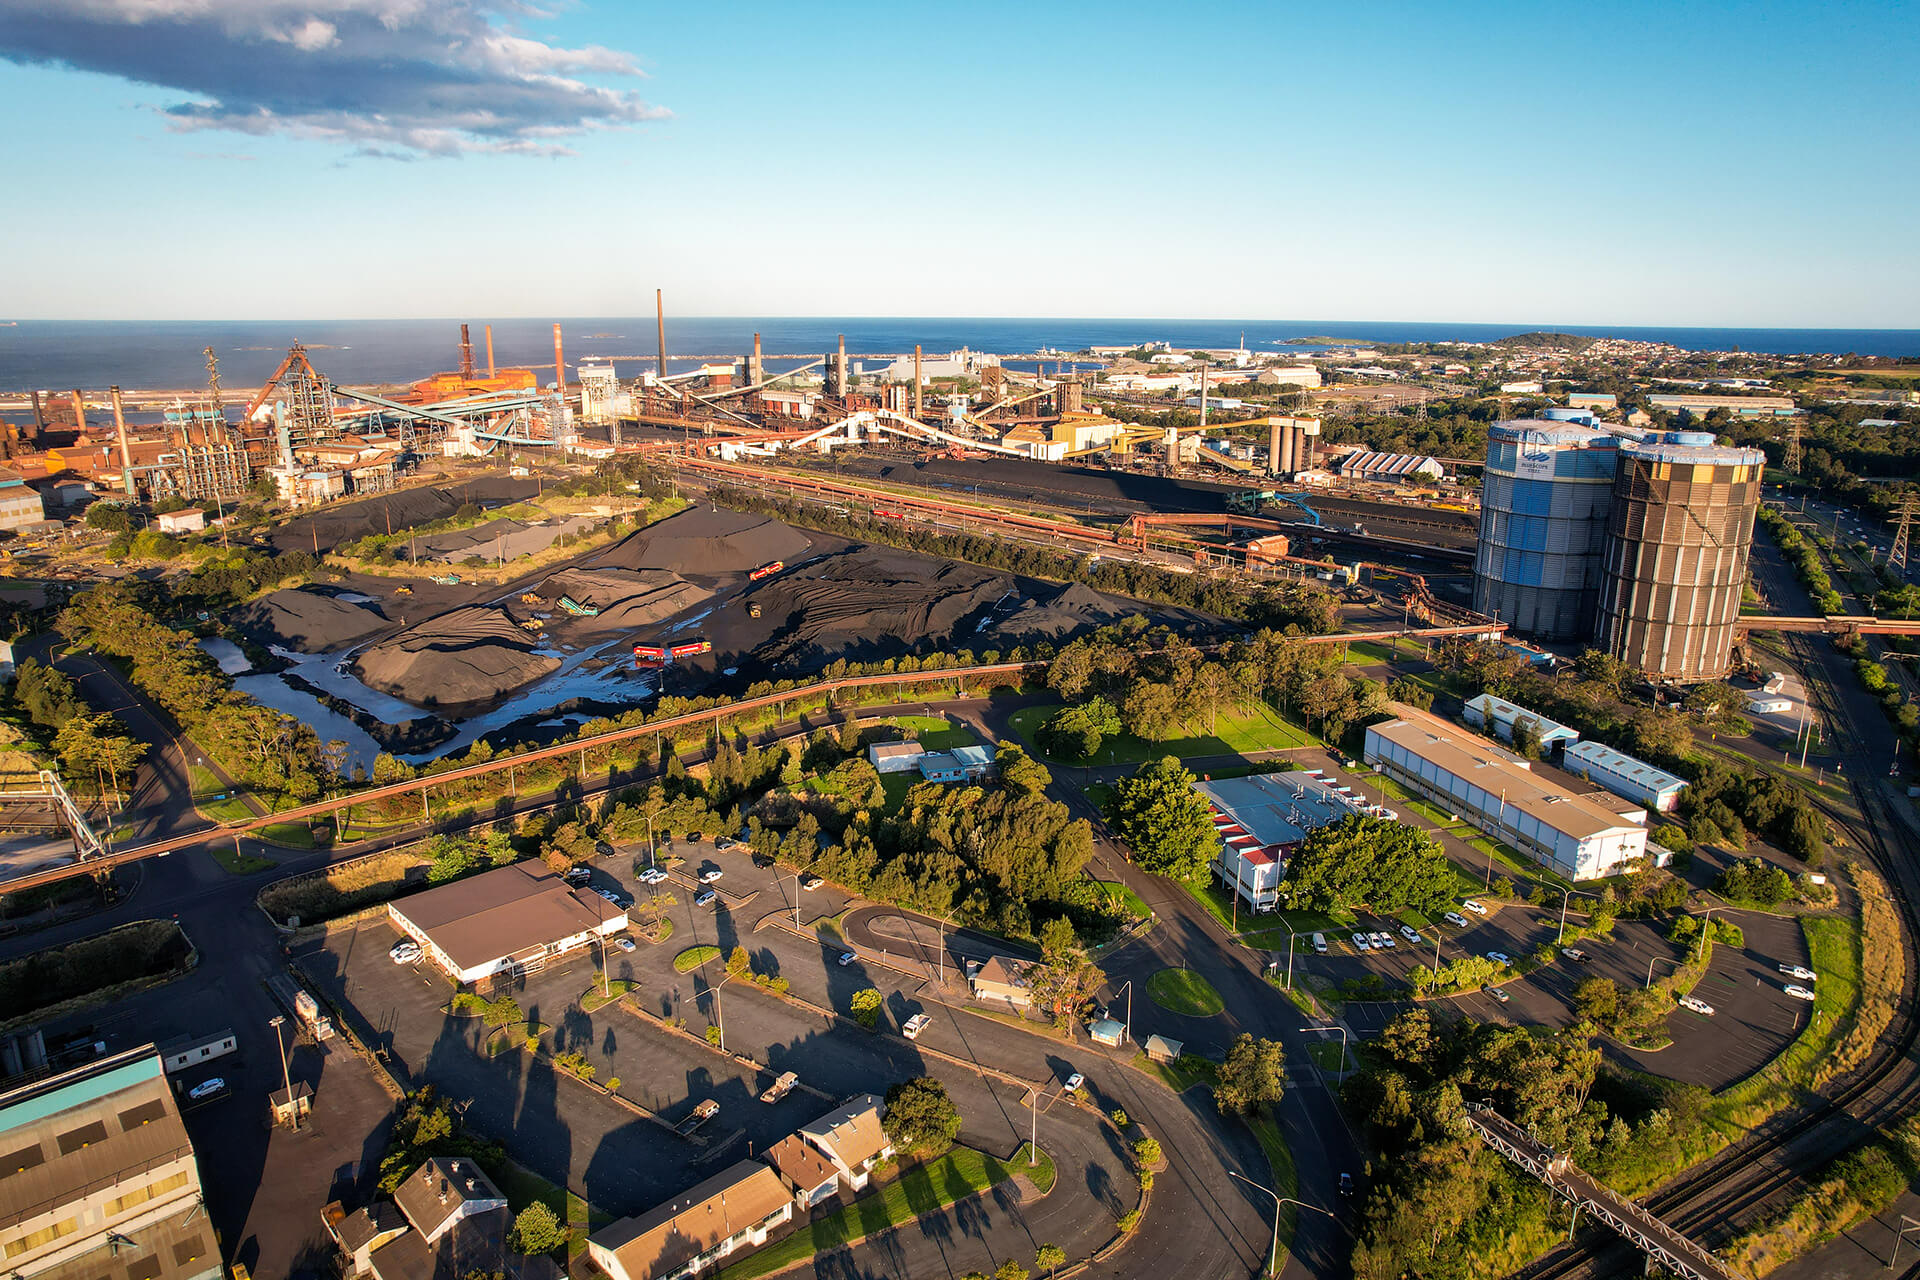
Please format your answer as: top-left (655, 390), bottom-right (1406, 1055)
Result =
top-left (1473, 418), bottom-right (1619, 641)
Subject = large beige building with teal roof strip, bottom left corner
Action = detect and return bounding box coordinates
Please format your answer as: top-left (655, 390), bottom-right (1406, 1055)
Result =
top-left (0, 1044), bottom-right (225, 1280)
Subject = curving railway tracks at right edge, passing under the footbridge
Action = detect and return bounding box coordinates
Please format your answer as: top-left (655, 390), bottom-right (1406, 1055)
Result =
top-left (1513, 633), bottom-right (1920, 1280)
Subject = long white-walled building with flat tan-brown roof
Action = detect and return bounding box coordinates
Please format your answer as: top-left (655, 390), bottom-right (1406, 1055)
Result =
top-left (1363, 702), bottom-right (1647, 881)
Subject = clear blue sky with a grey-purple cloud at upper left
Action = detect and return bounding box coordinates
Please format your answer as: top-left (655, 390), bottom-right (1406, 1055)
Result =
top-left (0, 0), bottom-right (1920, 328)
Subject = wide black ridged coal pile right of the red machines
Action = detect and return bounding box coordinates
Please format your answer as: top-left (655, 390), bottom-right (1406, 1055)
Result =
top-left (753, 547), bottom-right (1016, 666)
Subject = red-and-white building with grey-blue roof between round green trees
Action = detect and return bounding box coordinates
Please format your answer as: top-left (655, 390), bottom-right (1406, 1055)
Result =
top-left (1194, 770), bottom-right (1398, 912)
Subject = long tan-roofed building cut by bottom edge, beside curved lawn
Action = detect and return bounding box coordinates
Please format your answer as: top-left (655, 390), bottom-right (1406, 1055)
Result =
top-left (588, 1159), bottom-right (793, 1280)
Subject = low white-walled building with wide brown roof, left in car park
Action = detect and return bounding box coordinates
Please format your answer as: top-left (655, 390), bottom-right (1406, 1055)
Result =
top-left (386, 862), bottom-right (626, 983)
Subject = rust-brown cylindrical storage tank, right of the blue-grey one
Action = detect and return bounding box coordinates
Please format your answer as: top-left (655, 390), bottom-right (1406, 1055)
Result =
top-left (1599, 441), bottom-right (1766, 681)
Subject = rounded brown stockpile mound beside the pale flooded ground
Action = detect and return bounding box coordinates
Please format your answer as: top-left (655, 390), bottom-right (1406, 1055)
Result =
top-left (353, 604), bottom-right (561, 706)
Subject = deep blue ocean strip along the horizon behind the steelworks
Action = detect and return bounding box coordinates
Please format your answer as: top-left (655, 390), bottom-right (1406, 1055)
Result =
top-left (0, 315), bottom-right (1920, 391)
